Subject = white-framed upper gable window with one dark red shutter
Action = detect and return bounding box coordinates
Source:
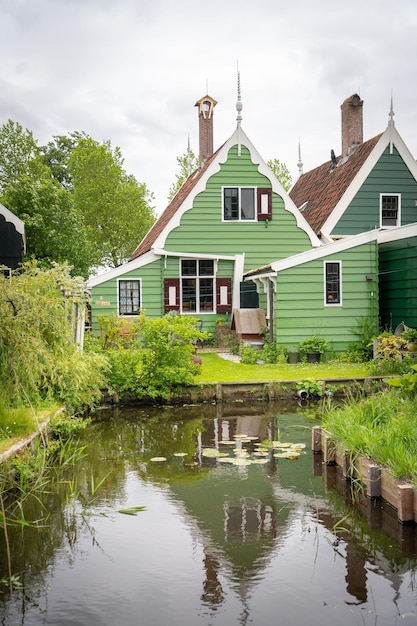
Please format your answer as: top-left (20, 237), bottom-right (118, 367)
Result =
top-left (223, 187), bottom-right (272, 222)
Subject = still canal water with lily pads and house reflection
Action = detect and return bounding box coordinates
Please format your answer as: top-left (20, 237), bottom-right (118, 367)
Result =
top-left (0, 403), bottom-right (417, 626)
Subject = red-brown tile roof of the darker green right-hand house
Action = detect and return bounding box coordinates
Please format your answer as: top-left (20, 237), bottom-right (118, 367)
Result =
top-left (290, 135), bottom-right (381, 235)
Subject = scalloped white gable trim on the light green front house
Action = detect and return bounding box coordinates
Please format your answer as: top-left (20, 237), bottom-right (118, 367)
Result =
top-left (153, 127), bottom-right (321, 248)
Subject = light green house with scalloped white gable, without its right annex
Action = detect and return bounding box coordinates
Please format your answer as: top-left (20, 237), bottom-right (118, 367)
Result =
top-left (89, 91), bottom-right (321, 331)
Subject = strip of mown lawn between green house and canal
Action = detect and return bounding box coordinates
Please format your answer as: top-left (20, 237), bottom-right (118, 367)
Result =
top-left (195, 352), bottom-right (369, 384)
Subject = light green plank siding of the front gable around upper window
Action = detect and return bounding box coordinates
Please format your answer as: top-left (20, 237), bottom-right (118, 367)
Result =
top-left (165, 146), bottom-right (311, 271)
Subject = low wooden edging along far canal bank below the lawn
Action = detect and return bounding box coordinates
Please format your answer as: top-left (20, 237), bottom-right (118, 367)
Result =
top-left (109, 376), bottom-right (389, 404)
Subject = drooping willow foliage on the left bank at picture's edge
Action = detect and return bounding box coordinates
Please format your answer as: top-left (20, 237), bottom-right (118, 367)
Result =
top-left (0, 262), bottom-right (106, 411)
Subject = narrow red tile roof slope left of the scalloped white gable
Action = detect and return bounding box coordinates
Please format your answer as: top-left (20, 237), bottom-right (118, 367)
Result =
top-left (129, 146), bottom-right (223, 261)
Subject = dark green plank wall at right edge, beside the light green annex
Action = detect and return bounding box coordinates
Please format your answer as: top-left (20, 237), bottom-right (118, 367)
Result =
top-left (379, 237), bottom-right (417, 331)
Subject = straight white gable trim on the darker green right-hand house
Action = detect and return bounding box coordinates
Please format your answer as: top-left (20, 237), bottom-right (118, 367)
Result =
top-left (321, 124), bottom-right (417, 238)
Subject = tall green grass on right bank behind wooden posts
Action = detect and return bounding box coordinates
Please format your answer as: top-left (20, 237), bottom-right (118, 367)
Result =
top-left (323, 390), bottom-right (417, 485)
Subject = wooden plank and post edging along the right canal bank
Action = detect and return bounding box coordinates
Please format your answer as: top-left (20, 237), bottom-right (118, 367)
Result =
top-left (311, 426), bottom-right (417, 523)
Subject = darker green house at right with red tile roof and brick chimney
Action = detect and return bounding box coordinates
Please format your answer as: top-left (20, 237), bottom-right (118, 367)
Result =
top-left (290, 94), bottom-right (417, 329)
